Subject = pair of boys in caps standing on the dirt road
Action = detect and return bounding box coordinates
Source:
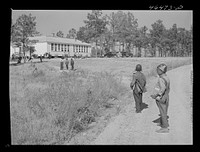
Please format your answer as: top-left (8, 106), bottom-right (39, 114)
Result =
top-left (130, 64), bottom-right (170, 133)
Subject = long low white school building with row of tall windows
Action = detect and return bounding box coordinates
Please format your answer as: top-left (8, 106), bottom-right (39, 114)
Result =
top-left (29, 36), bottom-right (91, 56)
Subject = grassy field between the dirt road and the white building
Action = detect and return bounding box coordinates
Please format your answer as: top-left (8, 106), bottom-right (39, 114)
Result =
top-left (9, 58), bottom-right (192, 144)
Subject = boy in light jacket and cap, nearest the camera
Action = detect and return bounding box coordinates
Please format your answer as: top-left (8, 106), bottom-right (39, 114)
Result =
top-left (151, 64), bottom-right (170, 133)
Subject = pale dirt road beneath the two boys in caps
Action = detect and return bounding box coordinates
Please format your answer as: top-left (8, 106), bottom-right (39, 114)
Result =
top-left (91, 65), bottom-right (193, 145)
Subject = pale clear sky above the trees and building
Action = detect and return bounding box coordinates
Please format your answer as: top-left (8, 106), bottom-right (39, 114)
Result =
top-left (11, 10), bottom-right (193, 36)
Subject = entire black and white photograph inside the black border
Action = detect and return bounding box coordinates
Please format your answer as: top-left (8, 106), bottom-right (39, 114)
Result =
top-left (9, 8), bottom-right (193, 145)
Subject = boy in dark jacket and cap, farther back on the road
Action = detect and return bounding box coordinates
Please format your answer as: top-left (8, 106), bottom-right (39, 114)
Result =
top-left (130, 64), bottom-right (146, 113)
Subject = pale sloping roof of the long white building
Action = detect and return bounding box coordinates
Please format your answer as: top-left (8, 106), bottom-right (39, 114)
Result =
top-left (29, 36), bottom-right (91, 46)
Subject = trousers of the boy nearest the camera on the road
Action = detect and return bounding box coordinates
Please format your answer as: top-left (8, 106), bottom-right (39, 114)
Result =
top-left (156, 96), bottom-right (169, 128)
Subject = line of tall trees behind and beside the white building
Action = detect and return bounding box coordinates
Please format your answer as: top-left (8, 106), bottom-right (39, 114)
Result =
top-left (11, 10), bottom-right (193, 57)
